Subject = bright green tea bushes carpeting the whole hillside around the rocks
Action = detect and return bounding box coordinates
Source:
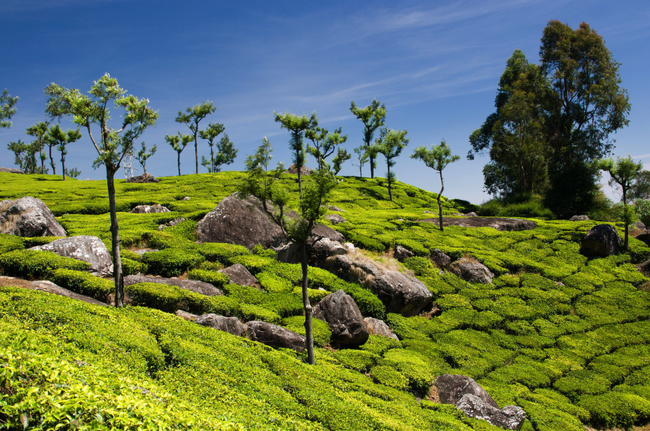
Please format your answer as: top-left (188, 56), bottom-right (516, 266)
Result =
top-left (0, 172), bottom-right (650, 431)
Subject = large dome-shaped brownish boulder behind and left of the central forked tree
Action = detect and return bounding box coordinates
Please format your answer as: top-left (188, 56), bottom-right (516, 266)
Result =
top-left (196, 194), bottom-right (287, 250)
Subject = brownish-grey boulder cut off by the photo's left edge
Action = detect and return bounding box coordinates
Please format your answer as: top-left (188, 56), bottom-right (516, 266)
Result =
top-left (0, 196), bottom-right (66, 237)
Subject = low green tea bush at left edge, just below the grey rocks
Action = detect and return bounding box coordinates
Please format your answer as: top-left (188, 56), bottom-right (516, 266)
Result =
top-left (0, 250), bottom-right (90, 280)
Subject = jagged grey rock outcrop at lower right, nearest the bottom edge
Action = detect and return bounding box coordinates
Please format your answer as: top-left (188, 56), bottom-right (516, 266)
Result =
top-left (433, 374), bottom-right (526, 430)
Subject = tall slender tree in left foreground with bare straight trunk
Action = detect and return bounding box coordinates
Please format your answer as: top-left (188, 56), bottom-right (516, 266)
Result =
top-left (45, 73), bottom-right (158, 307)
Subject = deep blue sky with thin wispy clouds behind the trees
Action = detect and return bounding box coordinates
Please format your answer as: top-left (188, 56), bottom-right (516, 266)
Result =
top-left (0, 0), bottom-right (650, 203)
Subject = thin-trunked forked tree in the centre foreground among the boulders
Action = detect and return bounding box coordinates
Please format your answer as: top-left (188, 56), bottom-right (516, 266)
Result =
top-left (238, 138), bottom-right (338, 364)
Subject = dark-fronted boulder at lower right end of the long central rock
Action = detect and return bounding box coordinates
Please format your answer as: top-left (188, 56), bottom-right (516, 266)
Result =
top-left (370, 271), bottom-right (433, 317)
